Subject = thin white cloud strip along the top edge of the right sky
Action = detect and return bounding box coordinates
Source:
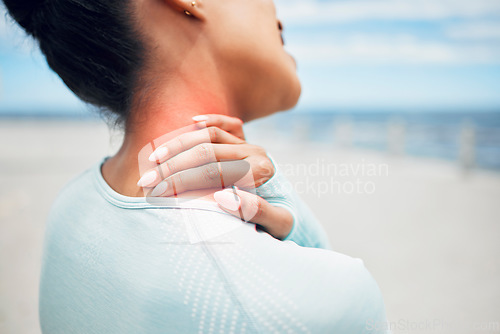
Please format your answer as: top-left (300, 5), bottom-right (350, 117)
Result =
top-left (278, 0), bottom-right (500, 24)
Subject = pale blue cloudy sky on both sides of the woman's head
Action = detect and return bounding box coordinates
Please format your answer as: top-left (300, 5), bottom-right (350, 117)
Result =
top-left (0, 0), bottom-right (500, 113)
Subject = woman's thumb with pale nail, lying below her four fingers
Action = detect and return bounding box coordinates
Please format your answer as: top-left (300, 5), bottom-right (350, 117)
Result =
top-left (214, 188), bottom-right (293, 239)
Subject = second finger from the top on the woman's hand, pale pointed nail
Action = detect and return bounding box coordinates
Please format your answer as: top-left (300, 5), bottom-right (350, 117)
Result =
top-left (149, 127), bottom-right (244, 163)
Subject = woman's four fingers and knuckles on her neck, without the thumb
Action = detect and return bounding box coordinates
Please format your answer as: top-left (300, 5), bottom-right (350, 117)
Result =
top-left (137, 115), bottom-right (275, 196)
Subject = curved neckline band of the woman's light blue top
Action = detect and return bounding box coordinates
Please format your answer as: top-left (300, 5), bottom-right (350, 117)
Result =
top-left (92, 157), bottom-right (228, 214)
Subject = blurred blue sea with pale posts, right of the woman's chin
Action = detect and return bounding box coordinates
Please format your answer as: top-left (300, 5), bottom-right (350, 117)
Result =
top-left (260, 110), bottom-right (500, 171)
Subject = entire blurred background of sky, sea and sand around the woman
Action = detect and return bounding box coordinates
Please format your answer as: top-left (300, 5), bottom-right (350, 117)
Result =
top-left (0, 0), bottom-right (500, 333)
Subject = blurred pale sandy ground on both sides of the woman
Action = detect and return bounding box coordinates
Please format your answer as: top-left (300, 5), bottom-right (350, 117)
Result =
top-left (0, 120), bottom-right (500, 334)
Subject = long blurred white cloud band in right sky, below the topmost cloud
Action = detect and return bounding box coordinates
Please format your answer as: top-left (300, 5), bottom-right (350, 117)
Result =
top-left (288, 34), bottom-right (500, 66)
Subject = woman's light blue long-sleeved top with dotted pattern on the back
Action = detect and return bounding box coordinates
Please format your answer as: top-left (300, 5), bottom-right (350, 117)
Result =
top-left (40, 157), bottom-right (386, 334)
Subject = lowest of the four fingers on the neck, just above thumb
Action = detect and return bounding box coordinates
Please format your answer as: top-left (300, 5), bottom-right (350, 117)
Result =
top-left (147, 160), bottom-right (250, 197)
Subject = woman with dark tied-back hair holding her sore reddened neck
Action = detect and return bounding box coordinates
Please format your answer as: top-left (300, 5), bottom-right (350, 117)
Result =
top-left (4, 0), bottom-right (385, 333)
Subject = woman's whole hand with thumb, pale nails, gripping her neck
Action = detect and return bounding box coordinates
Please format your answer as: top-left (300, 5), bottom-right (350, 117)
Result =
top-left (138, 114), bottom-right (293, 239)
